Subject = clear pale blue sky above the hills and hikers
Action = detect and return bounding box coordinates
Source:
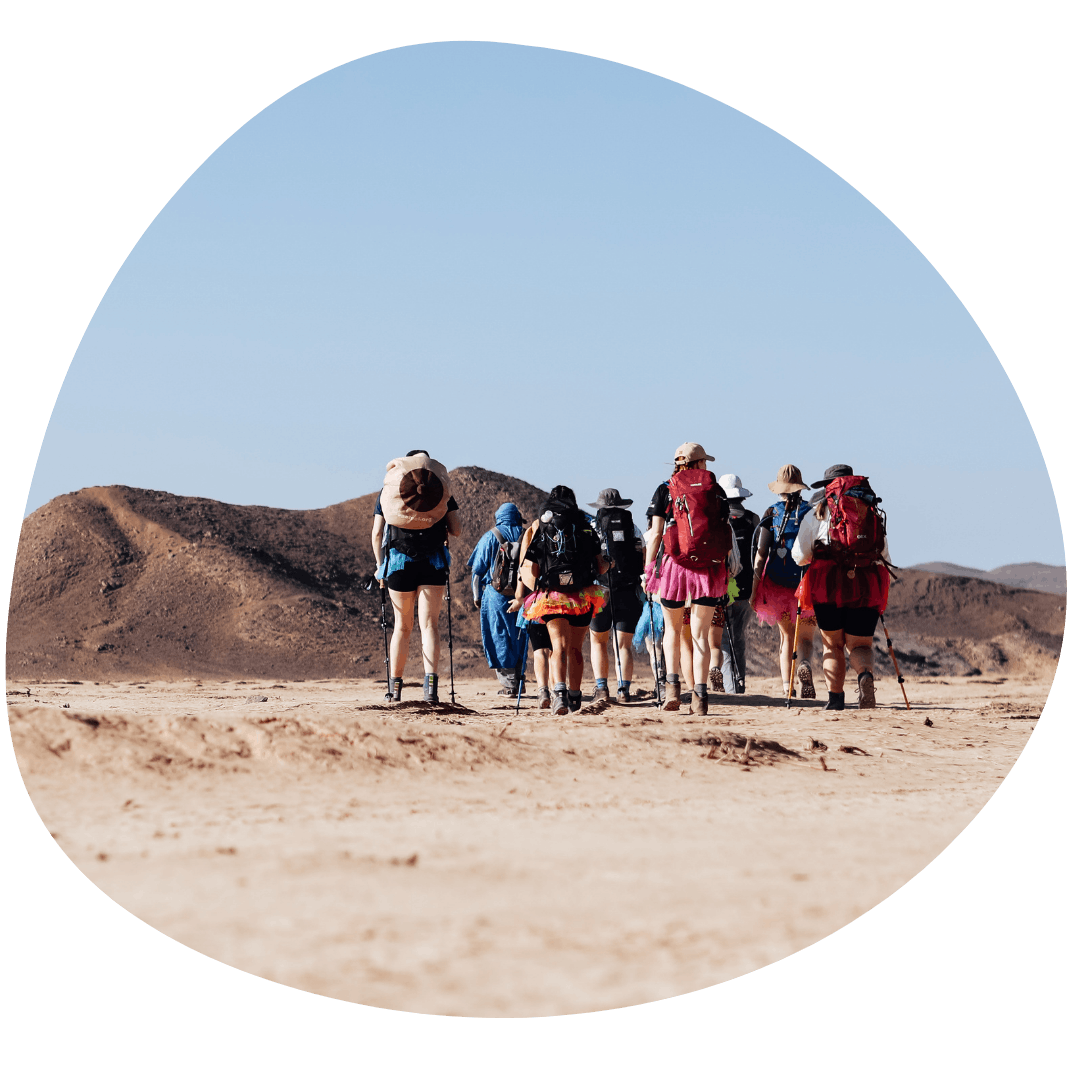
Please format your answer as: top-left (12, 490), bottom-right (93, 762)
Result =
top-left (27, 42), bottom-right (1065, 569)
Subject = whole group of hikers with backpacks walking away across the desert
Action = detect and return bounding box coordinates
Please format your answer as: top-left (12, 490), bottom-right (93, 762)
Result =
top-left (372, 443), bottom-right (899, 716)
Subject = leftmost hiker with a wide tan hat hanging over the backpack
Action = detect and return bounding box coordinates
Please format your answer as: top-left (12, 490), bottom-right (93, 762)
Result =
top-left (372, 450), bottom-right (461, 704)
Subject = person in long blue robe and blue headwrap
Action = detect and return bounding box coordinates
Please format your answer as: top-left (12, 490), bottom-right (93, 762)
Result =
top-left (468, 502), bottom-right (527, 698)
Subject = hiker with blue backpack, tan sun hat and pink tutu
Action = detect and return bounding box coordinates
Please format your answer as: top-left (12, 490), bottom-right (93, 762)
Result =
top-left (750, 465), bottom-right (818, 699)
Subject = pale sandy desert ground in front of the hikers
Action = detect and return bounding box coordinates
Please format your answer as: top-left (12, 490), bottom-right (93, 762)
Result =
top-left (6, 676), bottom-right (1051, 1016)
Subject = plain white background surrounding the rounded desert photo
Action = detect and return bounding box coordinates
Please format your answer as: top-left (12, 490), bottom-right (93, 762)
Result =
top-left (0, 0), bottom-right (1077, 1077)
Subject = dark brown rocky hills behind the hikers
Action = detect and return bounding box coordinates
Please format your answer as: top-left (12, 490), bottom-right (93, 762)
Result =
top-left (6, 465), bottom-right (1065, 683)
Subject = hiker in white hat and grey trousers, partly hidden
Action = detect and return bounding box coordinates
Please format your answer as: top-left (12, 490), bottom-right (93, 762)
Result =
top-left (708, 473), bottom-right (761, 693)
